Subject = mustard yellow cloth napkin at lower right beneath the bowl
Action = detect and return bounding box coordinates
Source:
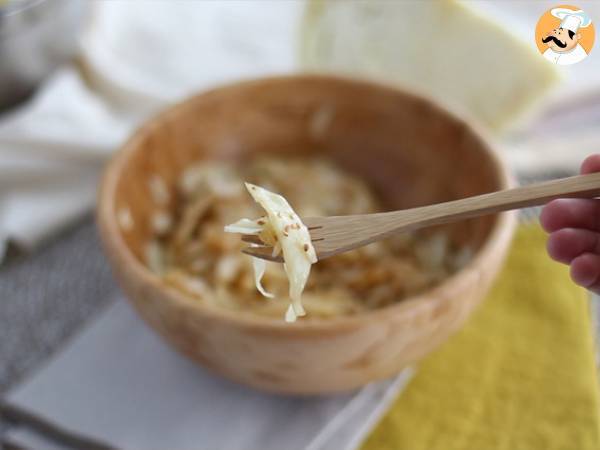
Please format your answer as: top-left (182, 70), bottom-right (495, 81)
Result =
top-left (363, 225), bottom-right (600, 450)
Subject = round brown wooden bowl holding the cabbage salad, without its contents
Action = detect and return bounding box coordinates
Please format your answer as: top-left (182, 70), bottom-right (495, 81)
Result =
top-left (98, 75), bottom-right (515, 394)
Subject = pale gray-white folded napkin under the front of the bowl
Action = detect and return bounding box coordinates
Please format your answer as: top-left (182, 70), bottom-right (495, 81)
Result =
top-left (6, 300), bottom-right (411, 450)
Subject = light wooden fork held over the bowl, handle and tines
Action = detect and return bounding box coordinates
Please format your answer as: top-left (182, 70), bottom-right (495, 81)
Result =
top-left (242, 173), bottom-right (600, 262)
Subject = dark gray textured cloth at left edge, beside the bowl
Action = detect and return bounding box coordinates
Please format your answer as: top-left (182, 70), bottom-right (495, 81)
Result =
top-left (0, 217), bottom-right (118, 393)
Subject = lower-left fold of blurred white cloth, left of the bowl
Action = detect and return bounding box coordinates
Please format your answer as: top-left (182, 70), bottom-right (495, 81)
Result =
top-left (0, 68), bottom-right (128, 261)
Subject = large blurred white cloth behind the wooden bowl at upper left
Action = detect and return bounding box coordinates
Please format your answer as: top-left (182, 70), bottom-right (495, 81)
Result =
top-left (0, 0), bottom-right (303, 261)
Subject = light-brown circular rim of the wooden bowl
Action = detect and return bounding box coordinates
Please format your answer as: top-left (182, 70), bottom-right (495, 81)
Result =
top-left (96, 73), bottom-right (517, 334)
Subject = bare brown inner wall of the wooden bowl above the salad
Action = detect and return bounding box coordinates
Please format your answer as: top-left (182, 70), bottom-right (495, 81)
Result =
top-left (106, 76), bottom-right (506, 274)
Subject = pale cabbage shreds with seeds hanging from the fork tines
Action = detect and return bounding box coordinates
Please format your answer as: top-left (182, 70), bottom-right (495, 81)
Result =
top-left (225, 183), bottom-right (317, 322)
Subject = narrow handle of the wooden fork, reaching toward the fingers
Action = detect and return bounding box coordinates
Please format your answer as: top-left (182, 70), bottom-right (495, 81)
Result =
top-left (381, 173), bottom-right (600, 229)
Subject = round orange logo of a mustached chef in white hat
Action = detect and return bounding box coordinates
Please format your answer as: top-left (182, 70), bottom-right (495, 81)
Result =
top-left (535, 5), bottom-right (596, 66)
